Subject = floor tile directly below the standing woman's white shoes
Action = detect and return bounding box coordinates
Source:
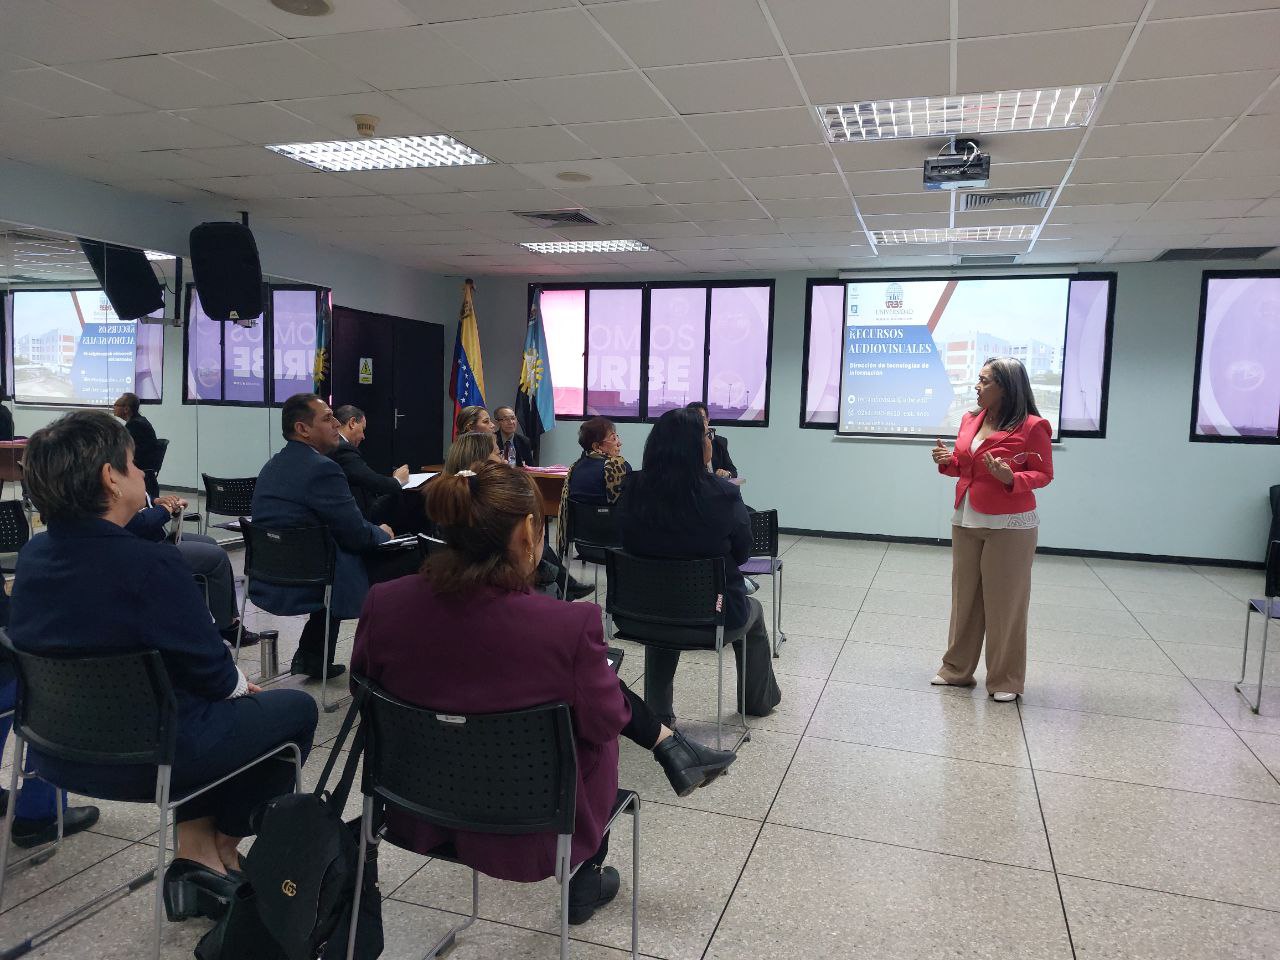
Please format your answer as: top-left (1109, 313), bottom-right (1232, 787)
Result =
top-left (806, 681), bottom-right (1028, 767)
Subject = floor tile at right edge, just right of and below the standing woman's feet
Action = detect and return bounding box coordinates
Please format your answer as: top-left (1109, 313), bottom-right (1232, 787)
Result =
top-left (1023, 705), bottom-right (1280, 803)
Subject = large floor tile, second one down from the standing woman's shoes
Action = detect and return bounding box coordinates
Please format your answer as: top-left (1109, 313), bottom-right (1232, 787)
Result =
top-left (769, 737), bottom-right (1051, 870)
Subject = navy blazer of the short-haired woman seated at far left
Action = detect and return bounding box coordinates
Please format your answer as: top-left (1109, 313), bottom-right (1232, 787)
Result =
top-left (9, 517), bottom-right (239, 756)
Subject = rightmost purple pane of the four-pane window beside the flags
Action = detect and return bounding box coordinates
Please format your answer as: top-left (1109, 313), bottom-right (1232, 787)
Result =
top-left (707, 287), bottom-right (772, 422)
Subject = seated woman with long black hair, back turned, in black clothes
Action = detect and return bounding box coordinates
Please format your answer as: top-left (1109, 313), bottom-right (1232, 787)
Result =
top-left (614, 410), bottom-right (782, 726)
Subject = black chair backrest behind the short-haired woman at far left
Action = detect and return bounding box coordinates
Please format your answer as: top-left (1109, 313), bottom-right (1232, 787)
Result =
top-left (0, 630), bottom-right (178, 765)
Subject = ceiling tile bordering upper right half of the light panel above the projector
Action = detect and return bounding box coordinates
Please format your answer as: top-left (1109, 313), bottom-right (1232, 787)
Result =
top-left (956, 26), bottom-right (1133, 93)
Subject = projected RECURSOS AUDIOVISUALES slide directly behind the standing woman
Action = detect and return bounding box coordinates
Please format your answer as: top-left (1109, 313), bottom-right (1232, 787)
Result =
top-left (837, 276), bottom-right (1070, 438)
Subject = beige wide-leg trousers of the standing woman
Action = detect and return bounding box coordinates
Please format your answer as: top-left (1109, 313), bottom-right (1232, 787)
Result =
top-left (938, 526), bottom-right (1038, 694)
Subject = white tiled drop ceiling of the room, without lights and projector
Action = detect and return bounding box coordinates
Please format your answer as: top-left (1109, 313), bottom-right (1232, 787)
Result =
top-left (0, 0), bottom-right (1280, 271)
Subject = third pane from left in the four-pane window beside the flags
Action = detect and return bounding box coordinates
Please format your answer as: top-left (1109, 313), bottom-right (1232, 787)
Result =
top-left (649, 287), bottom-right (707, 417)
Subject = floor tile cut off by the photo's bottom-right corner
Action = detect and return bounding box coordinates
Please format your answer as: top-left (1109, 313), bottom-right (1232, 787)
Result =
top-left (1061, 877), bottom-right (1280, 960)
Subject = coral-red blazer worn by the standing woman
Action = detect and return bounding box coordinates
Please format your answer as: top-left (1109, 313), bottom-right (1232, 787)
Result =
top-left (938, 413), bottom-right (1053, 513)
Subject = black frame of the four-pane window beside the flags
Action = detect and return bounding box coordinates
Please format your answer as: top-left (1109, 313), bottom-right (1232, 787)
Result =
top-left (527, 278), bottom-right (777, 428)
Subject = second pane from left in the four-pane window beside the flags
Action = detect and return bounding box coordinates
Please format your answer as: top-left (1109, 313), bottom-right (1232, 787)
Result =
top-left (586, 289), bottom-right (643, 417)
